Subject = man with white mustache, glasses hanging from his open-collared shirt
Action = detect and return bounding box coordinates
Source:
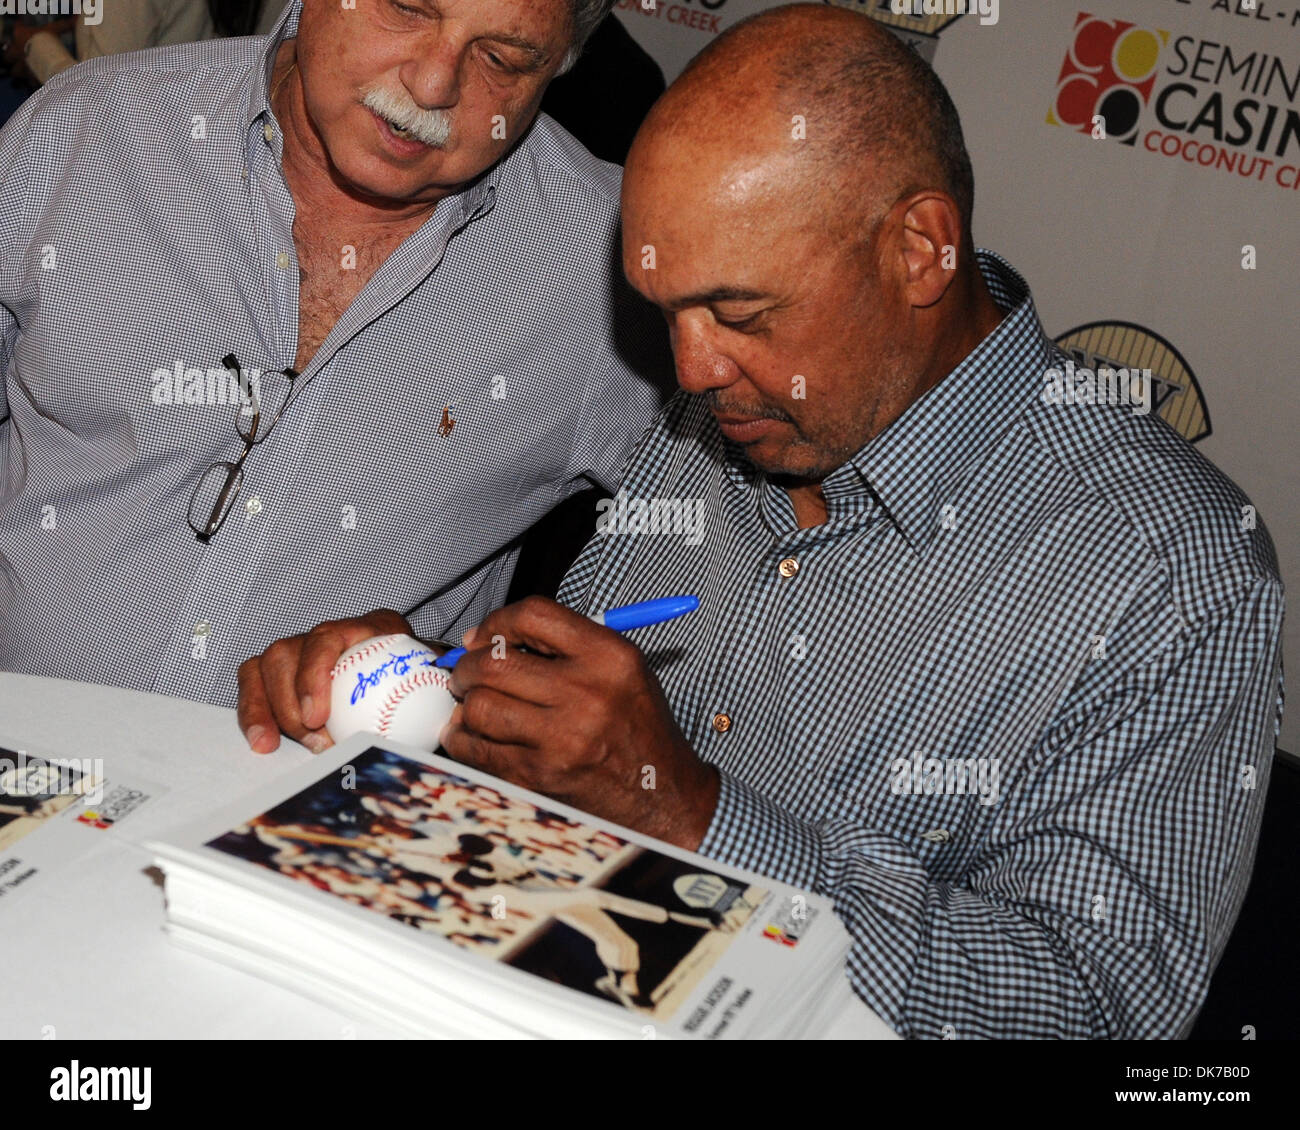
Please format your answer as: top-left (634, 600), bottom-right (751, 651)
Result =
top-left (0, 0), bottom-right (668, 705)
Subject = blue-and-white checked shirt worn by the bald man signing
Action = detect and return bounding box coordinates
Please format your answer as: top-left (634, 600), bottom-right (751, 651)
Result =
top-left (560, 251), bottom-right (1282, 1039)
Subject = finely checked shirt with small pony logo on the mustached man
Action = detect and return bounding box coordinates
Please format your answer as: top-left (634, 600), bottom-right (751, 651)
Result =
top-left (0, 3), bottom-right (671, 705)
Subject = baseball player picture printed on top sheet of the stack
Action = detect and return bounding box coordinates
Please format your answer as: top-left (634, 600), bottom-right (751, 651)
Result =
top-left (212, 749), bottom-right (766, 1018)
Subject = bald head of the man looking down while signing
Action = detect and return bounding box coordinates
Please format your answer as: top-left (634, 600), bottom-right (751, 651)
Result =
top-left (623, 4), bottom-right (1002, 492)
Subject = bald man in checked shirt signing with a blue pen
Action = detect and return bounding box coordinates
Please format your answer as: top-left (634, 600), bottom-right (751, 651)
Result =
top-left (244, 5), bottom-right (1282, 1038)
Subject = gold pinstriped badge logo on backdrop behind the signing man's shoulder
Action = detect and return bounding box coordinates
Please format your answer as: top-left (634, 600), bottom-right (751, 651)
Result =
top-left (1056, 321), bottom-right (1210, 443)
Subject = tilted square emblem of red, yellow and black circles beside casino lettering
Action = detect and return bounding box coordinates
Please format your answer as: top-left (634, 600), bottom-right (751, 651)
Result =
top-left (1048, 12), bottom-right (1169, 146)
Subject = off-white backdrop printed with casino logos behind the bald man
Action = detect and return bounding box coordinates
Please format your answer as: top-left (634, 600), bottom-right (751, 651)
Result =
top-left (616, 0), bottom-right (1300, 753)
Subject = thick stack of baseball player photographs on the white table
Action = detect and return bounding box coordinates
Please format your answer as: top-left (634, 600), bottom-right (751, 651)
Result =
top-left (151, 733), bottom-right (850, 1039)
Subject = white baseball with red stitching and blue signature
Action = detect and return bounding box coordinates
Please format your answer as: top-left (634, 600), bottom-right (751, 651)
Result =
top-left (325, 636), bottom-right (456, 752)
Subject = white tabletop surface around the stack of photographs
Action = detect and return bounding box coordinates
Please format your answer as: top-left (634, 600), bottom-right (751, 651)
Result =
top-left (0, 674), bottom-right (897, 1039)
